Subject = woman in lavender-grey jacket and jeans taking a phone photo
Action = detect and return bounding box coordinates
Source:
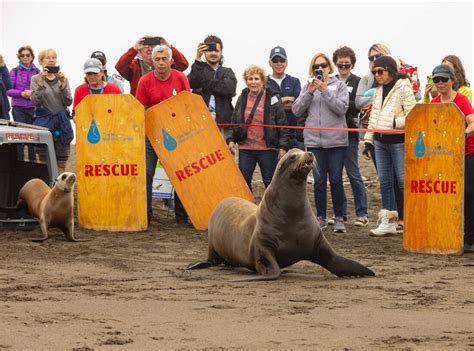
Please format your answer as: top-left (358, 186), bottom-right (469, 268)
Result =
top-left (292, 53), bottom-right (349, 233)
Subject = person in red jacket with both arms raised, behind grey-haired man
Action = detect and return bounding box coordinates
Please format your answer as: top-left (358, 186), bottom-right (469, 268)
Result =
top-left (115, 35), bottom-right (189, 96)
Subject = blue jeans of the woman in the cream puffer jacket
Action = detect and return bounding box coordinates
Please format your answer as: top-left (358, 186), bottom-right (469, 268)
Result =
top-left (374, 140), bottom-right (405, 219)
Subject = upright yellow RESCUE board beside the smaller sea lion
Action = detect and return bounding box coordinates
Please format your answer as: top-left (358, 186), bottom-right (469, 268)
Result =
top-left (76, 94), bottom-right (147, 231)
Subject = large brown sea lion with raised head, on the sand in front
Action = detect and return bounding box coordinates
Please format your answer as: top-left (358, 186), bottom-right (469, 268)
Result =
top-left (187, 149), bottom-right (375, 280)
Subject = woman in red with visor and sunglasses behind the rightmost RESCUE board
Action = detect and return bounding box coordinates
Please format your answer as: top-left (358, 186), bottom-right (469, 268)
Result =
top-left (431, 64), bottom-right (474, 252)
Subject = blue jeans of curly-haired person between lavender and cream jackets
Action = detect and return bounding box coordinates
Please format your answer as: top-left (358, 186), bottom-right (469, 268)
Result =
top-left (343, 138), bottom-right (368, 217)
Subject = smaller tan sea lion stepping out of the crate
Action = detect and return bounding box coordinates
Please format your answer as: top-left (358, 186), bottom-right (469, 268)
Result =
top-left (16, 172), bottom-right (87, 242)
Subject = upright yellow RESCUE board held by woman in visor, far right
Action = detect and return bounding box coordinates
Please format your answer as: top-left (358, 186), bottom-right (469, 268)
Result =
top-left (403, 104), bottom-right (465, 255)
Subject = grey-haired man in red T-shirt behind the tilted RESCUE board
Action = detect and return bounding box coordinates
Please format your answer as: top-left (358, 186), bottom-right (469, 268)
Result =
top-left (136, 45), bottom-right (191, 224)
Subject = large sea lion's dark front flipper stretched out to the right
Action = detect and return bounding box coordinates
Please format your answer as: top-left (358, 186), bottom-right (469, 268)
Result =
top-left (310, 233), bottom-right (375, 277)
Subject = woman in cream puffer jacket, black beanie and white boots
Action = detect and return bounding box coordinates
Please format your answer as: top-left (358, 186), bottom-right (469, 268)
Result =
top-left (363, 56), bottom-right (416, 236)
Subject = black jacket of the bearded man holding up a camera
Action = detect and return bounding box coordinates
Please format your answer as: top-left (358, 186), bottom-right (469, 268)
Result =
top-left (188, 61), bottom-right (237, 123)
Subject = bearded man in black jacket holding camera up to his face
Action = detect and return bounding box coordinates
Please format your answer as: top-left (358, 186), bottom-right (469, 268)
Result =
top-left (188, 35), bottom-right (237, 135)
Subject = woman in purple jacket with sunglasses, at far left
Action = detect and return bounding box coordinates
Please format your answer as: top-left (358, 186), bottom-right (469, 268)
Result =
top-left (7, 45), bottom-right (40, 124)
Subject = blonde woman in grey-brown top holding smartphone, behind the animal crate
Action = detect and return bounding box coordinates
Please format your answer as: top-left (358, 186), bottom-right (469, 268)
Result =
top-left (31, 49), bottom-right (72, 174)
